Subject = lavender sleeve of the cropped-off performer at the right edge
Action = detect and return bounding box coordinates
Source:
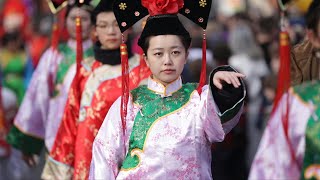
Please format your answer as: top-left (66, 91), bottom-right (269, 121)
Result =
top-left (248, 93), bottom-right (306, 180)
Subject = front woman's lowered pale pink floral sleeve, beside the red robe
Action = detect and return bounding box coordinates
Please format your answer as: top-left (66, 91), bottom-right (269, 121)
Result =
top-left (89, 98), bottom-right (130, 179)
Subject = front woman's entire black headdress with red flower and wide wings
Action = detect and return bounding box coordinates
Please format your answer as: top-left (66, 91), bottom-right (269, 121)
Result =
top-left (114, 0), bottom-right (212, 47)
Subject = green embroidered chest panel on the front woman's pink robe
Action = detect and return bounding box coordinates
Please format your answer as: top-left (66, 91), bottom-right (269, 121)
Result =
top-left (122, 84), bottom-right (196, 170)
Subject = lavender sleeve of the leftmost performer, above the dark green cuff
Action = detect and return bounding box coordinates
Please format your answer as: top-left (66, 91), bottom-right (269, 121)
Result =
top-left (13, 49), bottom-right (62, 143)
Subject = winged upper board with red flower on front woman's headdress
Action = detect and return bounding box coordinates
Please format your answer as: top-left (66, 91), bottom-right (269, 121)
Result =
top-left (113, 0), bottom-right (212, 32)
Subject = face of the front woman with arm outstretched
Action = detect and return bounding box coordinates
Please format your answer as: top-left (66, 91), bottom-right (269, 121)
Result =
top-left (144, 35), bottom-right (187, 85)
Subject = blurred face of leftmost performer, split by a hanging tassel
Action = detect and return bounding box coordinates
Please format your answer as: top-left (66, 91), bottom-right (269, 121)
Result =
top-left (67, 7), bottom-right (92, 40)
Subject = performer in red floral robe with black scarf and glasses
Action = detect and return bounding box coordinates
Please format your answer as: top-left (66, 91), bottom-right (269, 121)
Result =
top-left (42, 0), bottom-right (150, 179)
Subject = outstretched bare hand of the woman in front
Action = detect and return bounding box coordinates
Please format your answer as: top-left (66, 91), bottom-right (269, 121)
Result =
top-left (212, 71), bottom-right (245, 89)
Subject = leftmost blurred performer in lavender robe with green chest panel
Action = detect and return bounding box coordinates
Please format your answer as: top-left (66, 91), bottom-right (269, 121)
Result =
top-left (7, 1), bottom-right (93, 165)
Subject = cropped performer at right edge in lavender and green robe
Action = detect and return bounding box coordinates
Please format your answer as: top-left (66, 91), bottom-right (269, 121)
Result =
top-left (249, 0), bottom-right (320, 179)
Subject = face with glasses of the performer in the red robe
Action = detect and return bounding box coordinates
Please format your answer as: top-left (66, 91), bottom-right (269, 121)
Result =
top-left (95, 12), bottom-right (128, 50)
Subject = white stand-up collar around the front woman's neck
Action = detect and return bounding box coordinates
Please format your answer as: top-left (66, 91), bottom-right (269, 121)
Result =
top-left (148, 76), bottom-right (182, 97)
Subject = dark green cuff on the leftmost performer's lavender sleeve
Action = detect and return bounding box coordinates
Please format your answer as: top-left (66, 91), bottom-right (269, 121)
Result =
top-left (7, 126), bottom-right (44, 154)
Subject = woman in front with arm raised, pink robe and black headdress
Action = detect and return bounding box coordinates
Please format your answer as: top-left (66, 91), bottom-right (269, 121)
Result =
top-left (89, 0), bottom-right (245, 179)
